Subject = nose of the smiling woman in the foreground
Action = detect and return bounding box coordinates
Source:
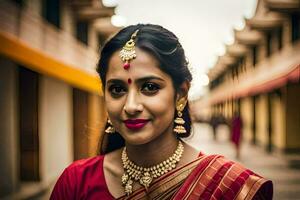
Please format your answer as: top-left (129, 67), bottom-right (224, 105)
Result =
top-left (124, 91), bottom-right (144, 115)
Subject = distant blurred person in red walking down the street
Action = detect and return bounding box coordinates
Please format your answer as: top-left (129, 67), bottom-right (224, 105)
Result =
top-left (231, 112), bottom-right (243, 159)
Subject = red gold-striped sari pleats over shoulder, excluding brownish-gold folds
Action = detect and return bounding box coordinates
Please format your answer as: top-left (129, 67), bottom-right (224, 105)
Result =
top-left (173, 155), bottom-right (273, 200)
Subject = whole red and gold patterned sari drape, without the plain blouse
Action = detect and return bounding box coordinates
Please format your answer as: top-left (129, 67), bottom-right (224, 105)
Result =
top-left (119, 155), bottom-right (273, 200)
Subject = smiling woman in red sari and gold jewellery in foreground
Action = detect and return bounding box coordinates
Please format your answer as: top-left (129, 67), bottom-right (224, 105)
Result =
top-left (51, 24), bottom-right (272, 200)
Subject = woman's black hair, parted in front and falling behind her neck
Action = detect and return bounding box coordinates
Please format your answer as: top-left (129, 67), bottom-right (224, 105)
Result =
top-left (97, 24), bottom-right (192, 154)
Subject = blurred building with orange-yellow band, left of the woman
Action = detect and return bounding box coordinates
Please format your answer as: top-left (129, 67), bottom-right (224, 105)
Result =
top-left (0, 0), bottom-right (118, 199)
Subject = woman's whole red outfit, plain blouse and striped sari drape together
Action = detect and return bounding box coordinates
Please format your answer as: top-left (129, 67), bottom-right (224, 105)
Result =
top-left (50, 155), bottom-right (273, 200)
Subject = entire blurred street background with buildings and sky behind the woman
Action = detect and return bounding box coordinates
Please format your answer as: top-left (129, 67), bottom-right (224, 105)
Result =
top-left (0, 0), bottom-right (300, 199)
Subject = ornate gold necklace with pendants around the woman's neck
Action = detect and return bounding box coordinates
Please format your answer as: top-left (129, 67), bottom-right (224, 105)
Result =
top-left (122, 141), bottom-right (184, 195)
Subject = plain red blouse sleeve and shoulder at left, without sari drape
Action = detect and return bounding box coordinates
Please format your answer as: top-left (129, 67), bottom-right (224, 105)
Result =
top-left (50, 156), bottom-right (115, 200)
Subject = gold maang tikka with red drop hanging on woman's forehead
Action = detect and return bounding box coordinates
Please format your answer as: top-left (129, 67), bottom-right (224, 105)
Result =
top-left (120, 29), bottom-right (139, 70)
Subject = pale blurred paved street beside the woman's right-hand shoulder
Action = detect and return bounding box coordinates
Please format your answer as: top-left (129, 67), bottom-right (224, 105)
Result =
top-left (188, 123), bottom-right (300, 200)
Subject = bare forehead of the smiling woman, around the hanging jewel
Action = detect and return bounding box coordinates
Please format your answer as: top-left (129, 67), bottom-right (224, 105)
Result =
top-left (106, 48), bottom-right (171, 80)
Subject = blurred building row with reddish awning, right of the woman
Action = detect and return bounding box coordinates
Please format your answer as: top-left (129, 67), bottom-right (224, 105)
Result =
top-left (194, 0), bottom-right (300, 152)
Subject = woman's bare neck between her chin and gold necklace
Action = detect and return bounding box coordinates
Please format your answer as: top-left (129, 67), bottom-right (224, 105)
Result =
top-left (126, 128), bottom-right (178, 167)
